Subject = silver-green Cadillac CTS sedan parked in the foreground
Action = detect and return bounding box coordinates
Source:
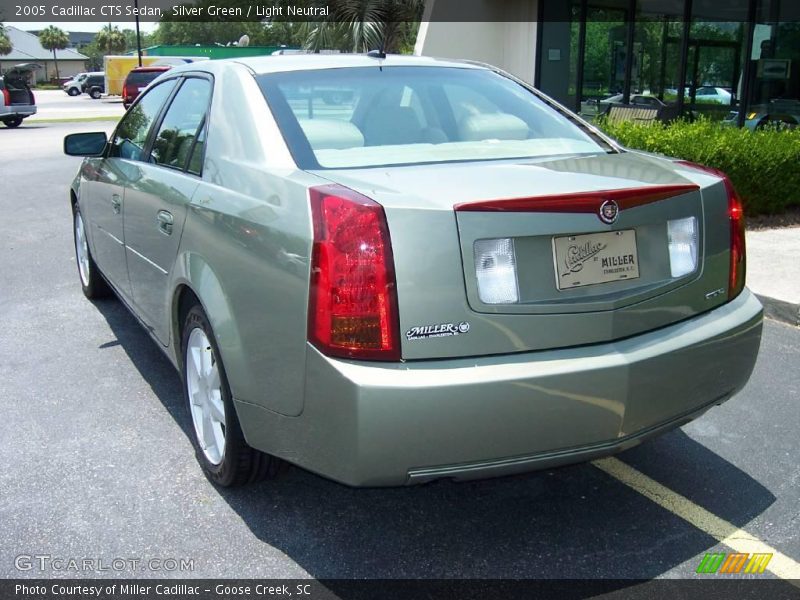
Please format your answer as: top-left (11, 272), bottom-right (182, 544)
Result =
top-left (65, 55), bottom-right (762, 486)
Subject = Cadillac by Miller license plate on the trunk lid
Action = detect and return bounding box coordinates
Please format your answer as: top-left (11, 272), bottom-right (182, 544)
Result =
top-left (553, 229), bottom-right (639, 290)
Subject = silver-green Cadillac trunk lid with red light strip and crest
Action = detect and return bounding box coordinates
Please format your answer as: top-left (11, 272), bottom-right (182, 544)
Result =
top-left (310, 153), bottom-right (729, 359)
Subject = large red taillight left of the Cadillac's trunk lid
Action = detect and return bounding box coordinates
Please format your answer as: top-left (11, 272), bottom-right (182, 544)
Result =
top-left (308, 185), bottom-right (400, 360)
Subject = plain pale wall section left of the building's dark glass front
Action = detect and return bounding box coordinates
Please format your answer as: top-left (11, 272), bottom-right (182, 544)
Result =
top-left (415, 0), bottom-right (538, 83)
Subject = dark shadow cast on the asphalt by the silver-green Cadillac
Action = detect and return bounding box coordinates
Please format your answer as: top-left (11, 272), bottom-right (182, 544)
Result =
top-left (95, 301), bottom-right (775, 586)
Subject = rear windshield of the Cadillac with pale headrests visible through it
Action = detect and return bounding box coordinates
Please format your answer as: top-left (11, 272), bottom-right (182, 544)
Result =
top-left (258, 66), bottom-right (611, 169)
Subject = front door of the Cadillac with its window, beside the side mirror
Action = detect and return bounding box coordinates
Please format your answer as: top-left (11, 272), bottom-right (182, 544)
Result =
top-left (92, 81), bottom-right (175, 300)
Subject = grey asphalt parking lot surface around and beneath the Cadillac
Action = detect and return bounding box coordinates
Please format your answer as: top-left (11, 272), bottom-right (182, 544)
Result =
top-left (0, 120), bottom-right (800, 579)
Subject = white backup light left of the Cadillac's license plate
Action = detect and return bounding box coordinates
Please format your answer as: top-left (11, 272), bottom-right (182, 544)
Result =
top-left (473, 238), bottom-right (519, 304)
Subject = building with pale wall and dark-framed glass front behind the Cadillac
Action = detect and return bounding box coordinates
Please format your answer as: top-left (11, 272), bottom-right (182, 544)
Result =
top-left (417, 0), bottom-right (800, 124)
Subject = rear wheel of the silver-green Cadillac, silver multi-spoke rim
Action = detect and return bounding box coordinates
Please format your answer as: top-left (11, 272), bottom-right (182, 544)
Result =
top-left (181, 305), bottom-right (284, 487)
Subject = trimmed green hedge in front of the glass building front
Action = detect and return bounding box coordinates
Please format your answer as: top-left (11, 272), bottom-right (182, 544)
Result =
top-left (597, 119), bottom-right (800, 215)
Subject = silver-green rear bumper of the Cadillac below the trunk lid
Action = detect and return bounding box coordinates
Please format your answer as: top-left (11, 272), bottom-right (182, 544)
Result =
top-left (237, 290), bottom-right (762, 486)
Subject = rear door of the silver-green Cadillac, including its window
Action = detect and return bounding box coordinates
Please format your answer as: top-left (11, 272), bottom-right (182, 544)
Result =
top-left (120, 75), bottom-right (212, 345)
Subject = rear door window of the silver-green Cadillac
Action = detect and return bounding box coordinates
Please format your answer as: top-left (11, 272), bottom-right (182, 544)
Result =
top-left (152, 78), bottom-right (211, 173)
